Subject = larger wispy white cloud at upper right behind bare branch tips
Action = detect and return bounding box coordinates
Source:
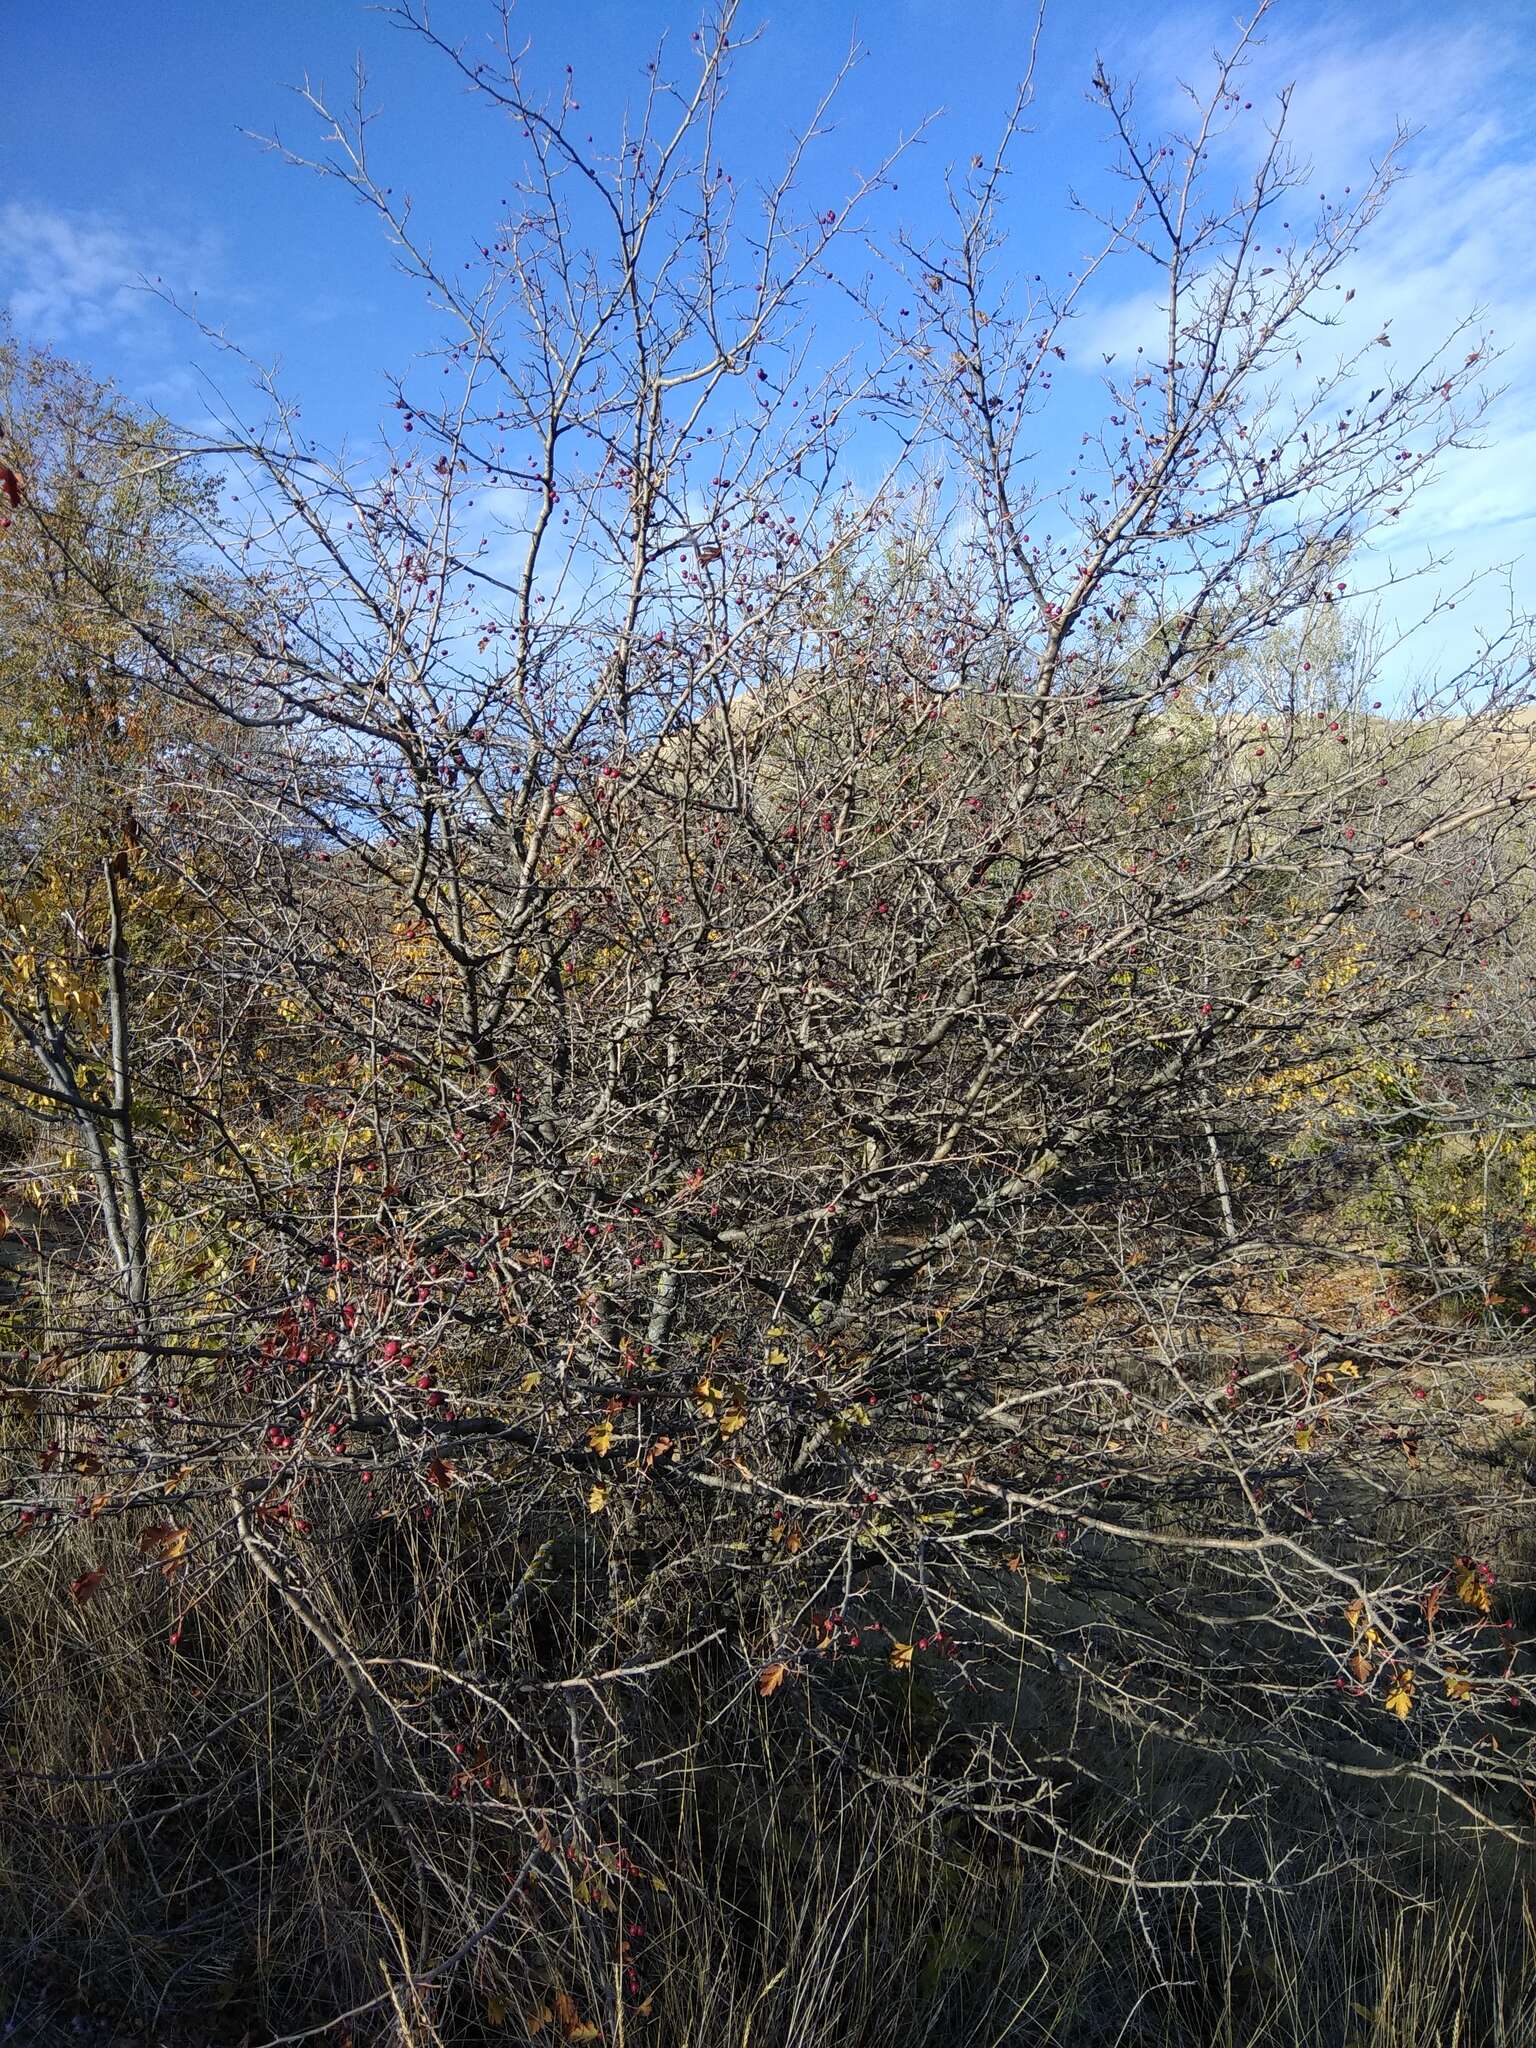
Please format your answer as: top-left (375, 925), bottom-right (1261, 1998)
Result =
top-left (1075, 8), bottom-right (1536, 667)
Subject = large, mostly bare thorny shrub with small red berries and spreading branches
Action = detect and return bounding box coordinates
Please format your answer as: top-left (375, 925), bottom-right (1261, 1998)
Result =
top-left (0, 4), bottom-right (1536, 2042)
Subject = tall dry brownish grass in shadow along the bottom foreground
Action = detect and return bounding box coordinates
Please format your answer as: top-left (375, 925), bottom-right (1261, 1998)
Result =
top-left (0, 1482), bottom-right (1536, 2048)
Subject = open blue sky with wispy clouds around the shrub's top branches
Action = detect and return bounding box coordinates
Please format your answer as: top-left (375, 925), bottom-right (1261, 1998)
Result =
top-left (0, 0), bottom-right (1536, 671)
